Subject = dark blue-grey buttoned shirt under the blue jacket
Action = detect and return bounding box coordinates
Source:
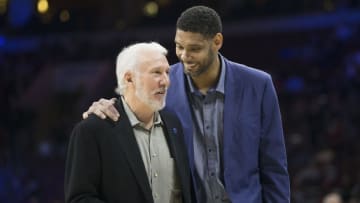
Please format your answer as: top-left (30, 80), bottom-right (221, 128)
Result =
top-left (186, 55), bottom-right (230, 203)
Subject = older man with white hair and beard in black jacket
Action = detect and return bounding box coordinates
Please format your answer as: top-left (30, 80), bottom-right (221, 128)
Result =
top-left (65, 42), bottom-right (192, 203)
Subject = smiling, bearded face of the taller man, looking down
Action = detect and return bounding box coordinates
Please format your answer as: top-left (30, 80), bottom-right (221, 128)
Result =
top-left (175, 29), bottom-right (222, 78)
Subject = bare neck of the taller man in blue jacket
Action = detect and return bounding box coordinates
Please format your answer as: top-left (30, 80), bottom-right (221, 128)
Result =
top-left (191, 57), bottom-right (221, 94)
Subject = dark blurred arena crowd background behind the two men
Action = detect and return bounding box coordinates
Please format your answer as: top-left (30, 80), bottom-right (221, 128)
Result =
top-left (0, 0), bottom-right (360, 203)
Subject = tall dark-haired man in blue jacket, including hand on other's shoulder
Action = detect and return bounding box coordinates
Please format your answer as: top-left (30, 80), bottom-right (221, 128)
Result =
top-left (83, 6), bottom-right (290, 203)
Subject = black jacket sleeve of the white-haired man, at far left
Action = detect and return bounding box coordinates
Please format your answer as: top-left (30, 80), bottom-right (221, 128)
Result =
top-left (64, 122), bottom-right (104, 203)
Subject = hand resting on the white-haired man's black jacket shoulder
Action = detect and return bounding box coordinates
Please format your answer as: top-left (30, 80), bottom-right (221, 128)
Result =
top-left (82, 98), bottom-right (120, 121)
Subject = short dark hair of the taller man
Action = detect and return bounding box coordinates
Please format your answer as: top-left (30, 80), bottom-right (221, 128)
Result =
top-left (176, 6), bottom-right (222, 37)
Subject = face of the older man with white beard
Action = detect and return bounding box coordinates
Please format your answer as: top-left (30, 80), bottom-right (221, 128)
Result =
top-left (134, 51), bottom-right (170, 111)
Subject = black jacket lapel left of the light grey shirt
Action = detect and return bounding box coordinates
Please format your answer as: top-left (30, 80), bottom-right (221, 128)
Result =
top-left (114, 100), bottom-right (153, 202)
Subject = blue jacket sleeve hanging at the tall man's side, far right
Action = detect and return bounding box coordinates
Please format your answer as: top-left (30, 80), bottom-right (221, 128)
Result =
top-left (260, 76), bottom-right (290, 203)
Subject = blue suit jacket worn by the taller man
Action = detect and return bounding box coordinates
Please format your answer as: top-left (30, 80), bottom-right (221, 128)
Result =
top-left (166, 58), bottom-right (290, 203)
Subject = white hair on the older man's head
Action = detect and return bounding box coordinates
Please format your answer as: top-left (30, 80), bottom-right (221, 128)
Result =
top-left (115, 42), bottom-right (168, 95)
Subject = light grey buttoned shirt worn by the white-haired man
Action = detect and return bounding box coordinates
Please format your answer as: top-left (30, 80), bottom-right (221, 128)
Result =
top-left (121, 98), bottom-right (182, 203)
